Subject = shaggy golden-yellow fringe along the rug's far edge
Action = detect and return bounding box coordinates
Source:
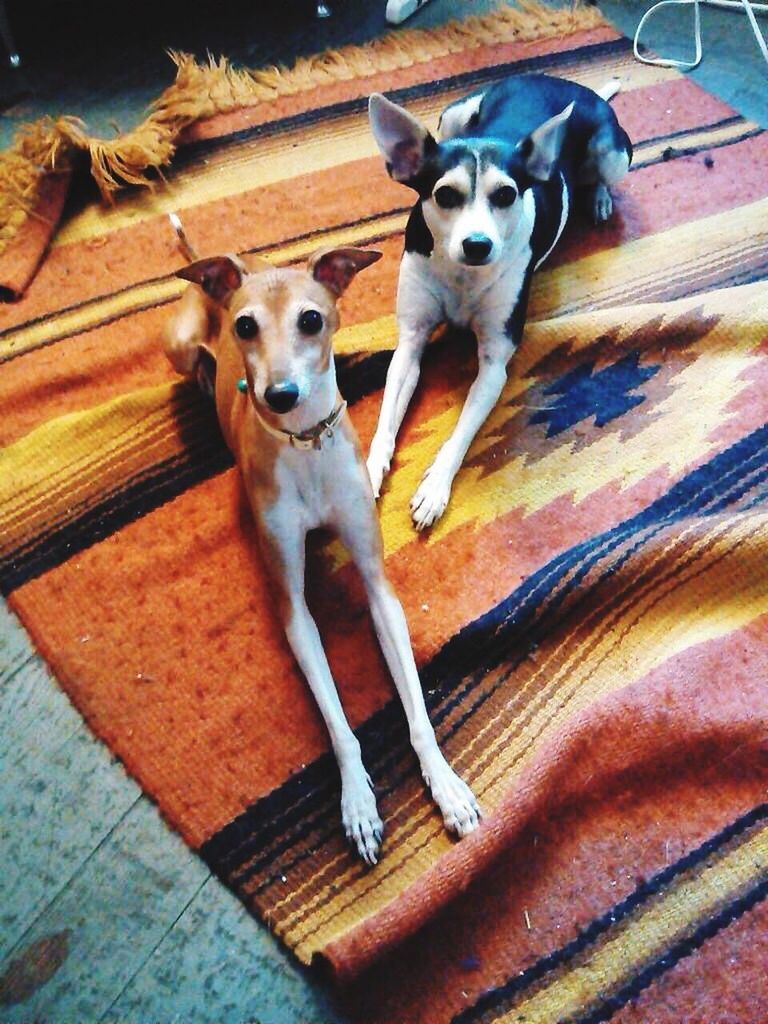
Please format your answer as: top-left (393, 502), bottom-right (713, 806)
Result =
top-left (0, 0), bottom-right (605, 253)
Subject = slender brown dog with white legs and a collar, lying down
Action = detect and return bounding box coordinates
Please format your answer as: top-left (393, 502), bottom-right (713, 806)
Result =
top-left (166, 248), bottom-right (479, 864)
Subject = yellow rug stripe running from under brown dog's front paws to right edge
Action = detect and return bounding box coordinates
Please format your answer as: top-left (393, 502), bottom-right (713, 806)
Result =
top-left (270, 514), bottom-right (768, 963)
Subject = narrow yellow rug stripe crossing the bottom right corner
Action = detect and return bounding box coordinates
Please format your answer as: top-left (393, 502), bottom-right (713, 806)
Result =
top-left (505, 826), bottom-right (768, 1024)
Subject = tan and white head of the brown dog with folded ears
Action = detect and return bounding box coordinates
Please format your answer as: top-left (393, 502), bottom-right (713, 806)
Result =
top-left (178, 247), bottom-right (381, 414)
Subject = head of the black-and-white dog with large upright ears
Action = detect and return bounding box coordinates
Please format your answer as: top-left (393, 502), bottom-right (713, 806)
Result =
top-left (369, 93), bottom-right (573, 266)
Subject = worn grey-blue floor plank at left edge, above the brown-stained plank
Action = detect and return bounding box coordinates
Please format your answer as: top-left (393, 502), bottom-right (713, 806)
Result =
top-left (0, 602), bottom-right (139, 956)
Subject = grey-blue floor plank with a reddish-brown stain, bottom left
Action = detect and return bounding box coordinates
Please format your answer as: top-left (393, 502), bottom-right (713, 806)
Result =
top-left (0, 800), bottom-right (209, 1024)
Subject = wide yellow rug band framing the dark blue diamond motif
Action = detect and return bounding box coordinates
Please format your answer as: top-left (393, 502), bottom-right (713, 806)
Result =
top-left (0, 283), bottom-right (768, 581)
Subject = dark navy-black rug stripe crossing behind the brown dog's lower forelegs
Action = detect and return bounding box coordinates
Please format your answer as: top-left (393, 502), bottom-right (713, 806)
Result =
top-left (201, 426), bottom-right (768, 881)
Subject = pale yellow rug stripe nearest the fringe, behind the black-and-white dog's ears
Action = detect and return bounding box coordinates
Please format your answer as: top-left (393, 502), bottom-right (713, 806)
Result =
top-left (53, 54), bottom-right (676, 247)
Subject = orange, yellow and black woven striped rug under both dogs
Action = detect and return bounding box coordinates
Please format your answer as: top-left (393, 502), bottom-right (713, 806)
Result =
top-left (0, 7), bottom-right (768, 1024)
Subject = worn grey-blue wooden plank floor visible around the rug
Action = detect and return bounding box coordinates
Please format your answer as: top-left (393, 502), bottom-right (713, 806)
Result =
top-left (0, 0), bottom-right (768, 1024)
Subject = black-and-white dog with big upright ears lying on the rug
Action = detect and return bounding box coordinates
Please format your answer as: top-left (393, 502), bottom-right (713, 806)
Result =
top-left (368, 75), bottom-right (632, 529)
